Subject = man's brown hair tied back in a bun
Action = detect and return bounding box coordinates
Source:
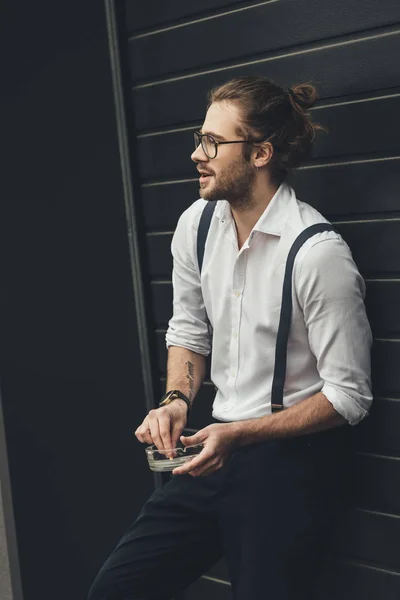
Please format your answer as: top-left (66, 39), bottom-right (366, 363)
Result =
top-left (208, 76), bottom-right (325, 184)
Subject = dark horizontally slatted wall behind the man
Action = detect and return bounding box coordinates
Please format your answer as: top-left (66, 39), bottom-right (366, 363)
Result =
top-left (122, 0), bottom-right (400, 600)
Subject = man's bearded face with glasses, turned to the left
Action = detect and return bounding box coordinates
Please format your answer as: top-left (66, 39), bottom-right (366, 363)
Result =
top-left (191, 102), bottom-right (256, 208)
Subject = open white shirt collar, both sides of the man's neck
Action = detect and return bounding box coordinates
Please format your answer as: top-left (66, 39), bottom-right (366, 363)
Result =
top-left (215, 183), bottom-right (296, 236)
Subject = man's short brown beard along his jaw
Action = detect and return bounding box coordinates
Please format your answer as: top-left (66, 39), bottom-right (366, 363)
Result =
top-left (199, 157), bottom-right (256, 210)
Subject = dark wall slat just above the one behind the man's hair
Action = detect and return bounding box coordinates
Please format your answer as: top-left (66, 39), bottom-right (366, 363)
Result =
top-left (129, 0), bottom-right (400, 80)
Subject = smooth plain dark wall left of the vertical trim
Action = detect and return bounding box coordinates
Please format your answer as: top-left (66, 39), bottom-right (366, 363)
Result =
top-left (0, 0), bottom-right (153, 600)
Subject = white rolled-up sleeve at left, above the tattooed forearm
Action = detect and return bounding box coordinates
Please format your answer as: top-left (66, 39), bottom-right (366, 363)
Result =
top-left (165, 205), bottom-right (211, 356)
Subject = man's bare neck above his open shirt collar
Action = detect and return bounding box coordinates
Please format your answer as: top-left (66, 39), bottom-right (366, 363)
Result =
top-left (231, 173), bottom-right (278, 246)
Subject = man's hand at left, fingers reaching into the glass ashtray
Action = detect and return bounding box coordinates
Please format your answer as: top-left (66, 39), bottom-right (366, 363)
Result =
top-left (135, 398), bottom-right (188, 450)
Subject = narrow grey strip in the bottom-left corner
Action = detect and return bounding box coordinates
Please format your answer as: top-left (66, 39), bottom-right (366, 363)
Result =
top-left (0, 390), bottom-right (23, 600)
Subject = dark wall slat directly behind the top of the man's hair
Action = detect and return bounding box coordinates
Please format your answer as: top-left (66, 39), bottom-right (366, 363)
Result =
top-left (133, 29), bottom-right (400, 131)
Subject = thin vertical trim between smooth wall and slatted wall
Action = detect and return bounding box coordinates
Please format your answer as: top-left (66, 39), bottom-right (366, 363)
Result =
top-left (104, 0), bottom-right (162, 487)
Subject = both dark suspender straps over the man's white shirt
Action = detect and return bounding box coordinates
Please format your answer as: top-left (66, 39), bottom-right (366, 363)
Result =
top-left (197, 202), bottom-right (335, 412)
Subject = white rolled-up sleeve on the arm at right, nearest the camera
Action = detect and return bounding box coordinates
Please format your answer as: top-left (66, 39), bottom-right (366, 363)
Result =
top-left (296, 237), bottom-right (372, 425)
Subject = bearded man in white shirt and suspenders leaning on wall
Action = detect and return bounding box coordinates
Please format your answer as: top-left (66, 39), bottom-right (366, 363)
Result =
top-left (90, 77), bottom-right (372, 600)
